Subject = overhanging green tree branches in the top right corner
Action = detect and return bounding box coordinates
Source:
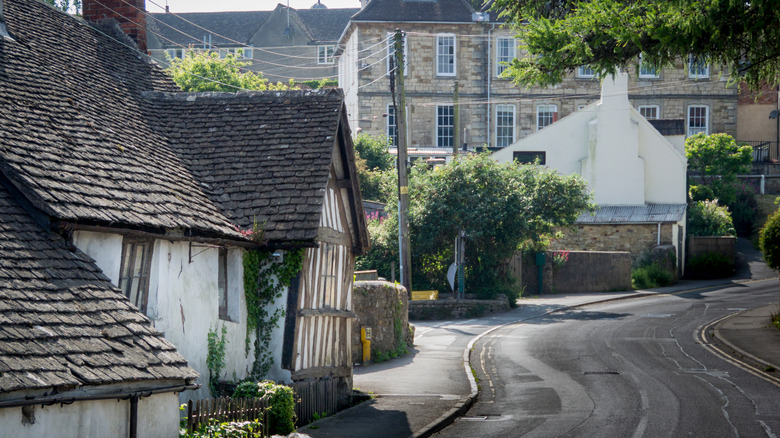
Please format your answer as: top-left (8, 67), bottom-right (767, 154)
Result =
top-left (493, 0), bottom-right (780, 89)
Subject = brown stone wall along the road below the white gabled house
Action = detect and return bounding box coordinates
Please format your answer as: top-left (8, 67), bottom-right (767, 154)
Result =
top-left (521, 251), bottom-right (632, 295)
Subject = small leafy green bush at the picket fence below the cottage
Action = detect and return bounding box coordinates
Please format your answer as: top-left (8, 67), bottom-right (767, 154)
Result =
top-left (233, 380), bottom-right (296, 435)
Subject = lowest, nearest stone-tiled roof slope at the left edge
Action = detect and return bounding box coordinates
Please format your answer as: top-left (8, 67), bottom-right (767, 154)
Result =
top-left (0, 185), bottom-right (197, 393)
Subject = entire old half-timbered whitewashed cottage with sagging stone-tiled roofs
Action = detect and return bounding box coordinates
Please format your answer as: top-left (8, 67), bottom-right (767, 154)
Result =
top-left (0, 0), bottom-right (368, 414)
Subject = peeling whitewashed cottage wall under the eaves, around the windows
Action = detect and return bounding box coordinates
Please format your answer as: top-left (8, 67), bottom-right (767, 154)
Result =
top-left (74, 232), bottom-right (291, 401)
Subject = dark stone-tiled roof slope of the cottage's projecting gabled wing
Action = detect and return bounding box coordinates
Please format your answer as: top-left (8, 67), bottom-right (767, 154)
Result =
top-left (144, 90), bottom-right (344, 242)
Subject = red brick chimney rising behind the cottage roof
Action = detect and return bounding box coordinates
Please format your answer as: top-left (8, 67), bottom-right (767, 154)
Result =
top-left (82, 0), bottom-right (146, 53)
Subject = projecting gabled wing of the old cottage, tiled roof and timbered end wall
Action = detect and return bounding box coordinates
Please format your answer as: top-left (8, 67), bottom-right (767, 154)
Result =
top-left (152, 90), bottom-right (368, 408)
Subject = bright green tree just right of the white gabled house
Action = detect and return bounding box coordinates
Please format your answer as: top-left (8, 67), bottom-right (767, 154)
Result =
top-left (685, 134), bottom-right (753, 205)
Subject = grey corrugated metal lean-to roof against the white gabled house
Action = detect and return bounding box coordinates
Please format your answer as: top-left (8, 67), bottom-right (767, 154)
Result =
top-left (577, 204), bottom-right (687, 224)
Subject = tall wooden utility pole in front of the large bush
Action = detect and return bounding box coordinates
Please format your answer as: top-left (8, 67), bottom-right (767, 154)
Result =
top-left (393, 29), bottom-right (412, 296)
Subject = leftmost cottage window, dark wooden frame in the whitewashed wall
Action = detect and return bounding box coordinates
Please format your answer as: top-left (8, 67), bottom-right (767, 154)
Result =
top-left (119, 238), bottom-right (153, 313)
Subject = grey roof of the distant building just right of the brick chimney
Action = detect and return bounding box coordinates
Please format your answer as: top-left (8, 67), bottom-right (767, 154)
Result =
top-left (146, 11), bottom-right (273, 47)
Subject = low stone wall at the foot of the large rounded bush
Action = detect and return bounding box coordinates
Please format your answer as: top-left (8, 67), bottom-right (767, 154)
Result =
top-left (409, 295), bottom-right (510, 321)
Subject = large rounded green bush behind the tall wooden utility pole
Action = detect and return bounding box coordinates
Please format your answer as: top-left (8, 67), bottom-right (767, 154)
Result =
top-left (354, 154), bottom-right (590, 303)
